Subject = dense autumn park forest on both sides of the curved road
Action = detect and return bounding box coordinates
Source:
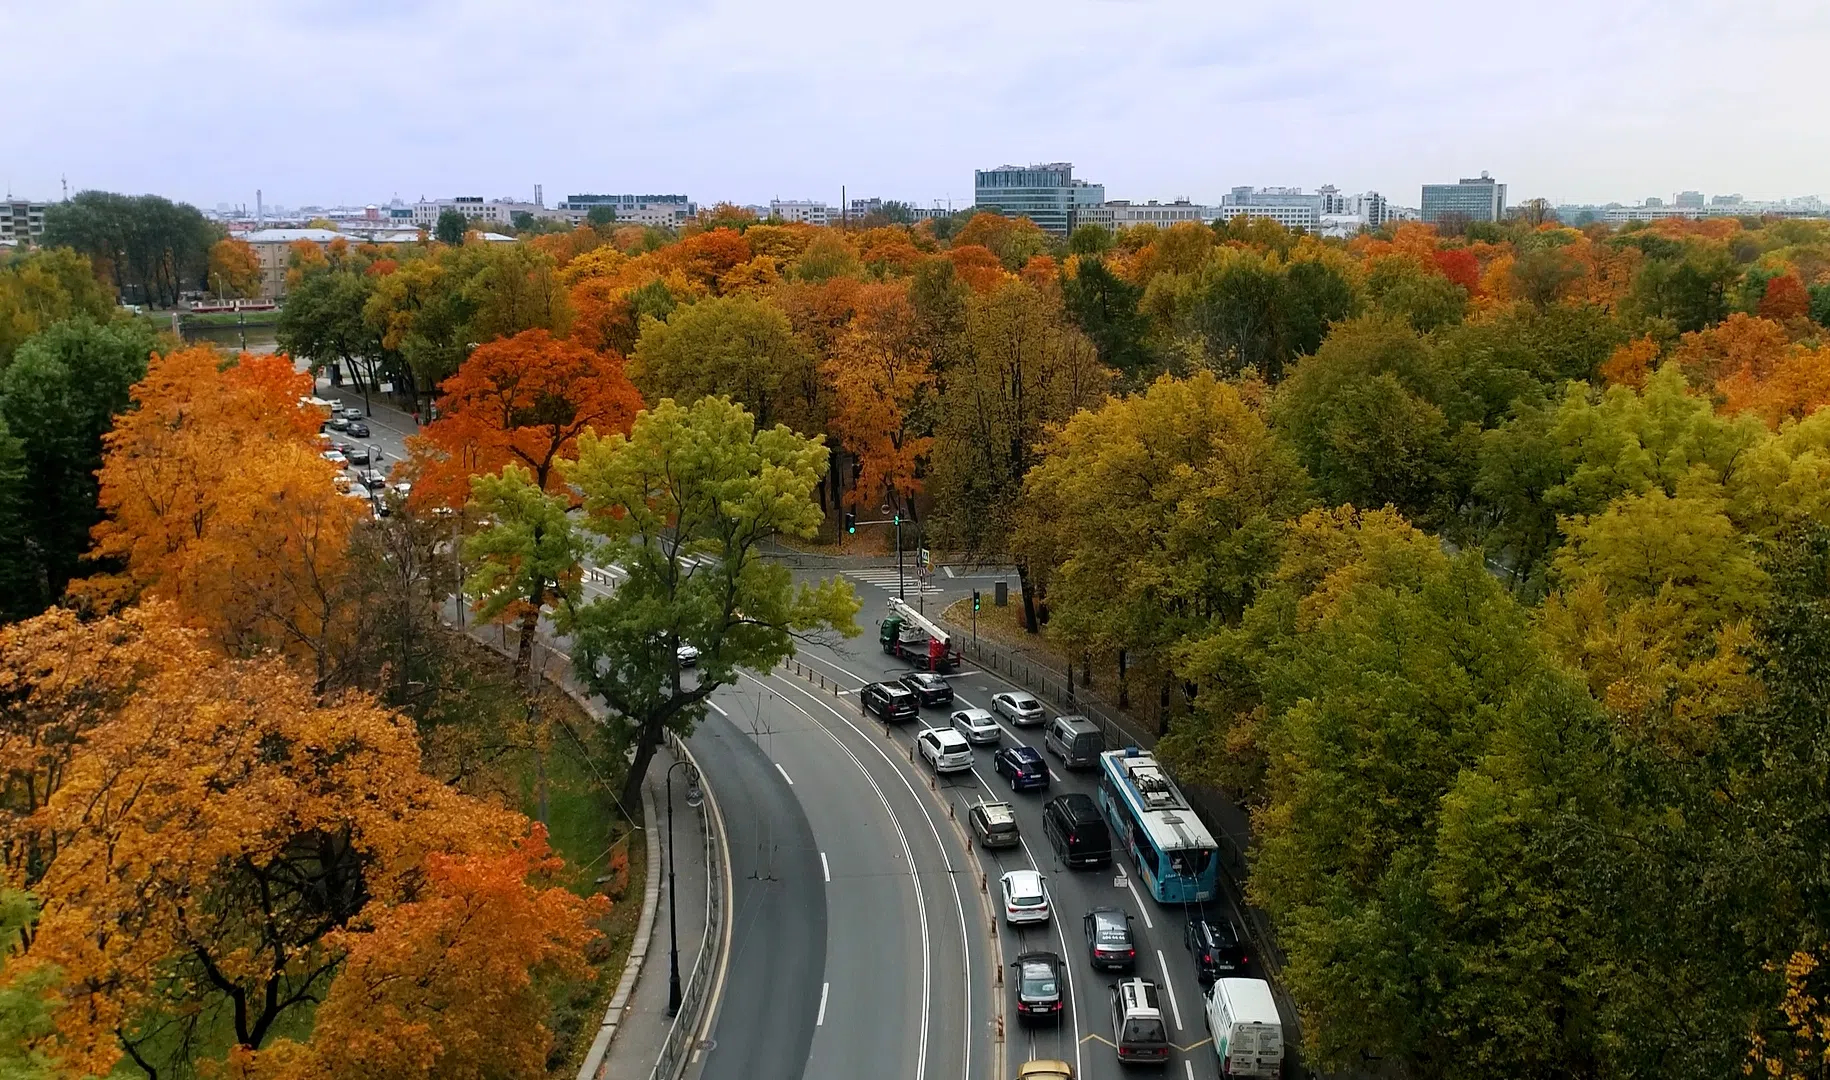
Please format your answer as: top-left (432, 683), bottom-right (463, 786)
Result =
top-left (0, 196), bottom-right (1830, 1080)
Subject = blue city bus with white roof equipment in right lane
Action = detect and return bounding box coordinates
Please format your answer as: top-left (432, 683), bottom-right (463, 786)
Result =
top-left (1100, 747), bottom-right (1221, 904)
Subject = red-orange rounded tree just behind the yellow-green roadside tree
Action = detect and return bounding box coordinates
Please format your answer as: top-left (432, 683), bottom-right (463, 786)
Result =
top-left (404, 329), bottom-right (642, 509)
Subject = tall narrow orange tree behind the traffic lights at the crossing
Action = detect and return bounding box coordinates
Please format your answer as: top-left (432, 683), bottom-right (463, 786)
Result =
top-left (824, 284), bottom-right (935, 509)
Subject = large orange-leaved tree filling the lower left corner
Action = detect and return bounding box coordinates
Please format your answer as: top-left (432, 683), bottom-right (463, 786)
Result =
top-left (0, 606), bottom-right (602, 1075)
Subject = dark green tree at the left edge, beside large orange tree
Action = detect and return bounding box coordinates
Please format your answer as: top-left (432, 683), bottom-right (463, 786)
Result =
top-left (0, 317), bottom-right (154, 619)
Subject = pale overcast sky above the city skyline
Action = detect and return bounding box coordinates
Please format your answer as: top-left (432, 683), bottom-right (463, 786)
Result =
top-left (0, 0), bottom-right (1830, 207)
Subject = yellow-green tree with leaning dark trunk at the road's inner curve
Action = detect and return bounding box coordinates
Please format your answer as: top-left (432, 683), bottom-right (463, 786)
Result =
top-left (562, 397), bottom-right (858, 805)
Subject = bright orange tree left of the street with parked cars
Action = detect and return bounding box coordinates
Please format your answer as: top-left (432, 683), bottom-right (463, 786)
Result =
top-left (85, 348), bottom-right (364, 686)
